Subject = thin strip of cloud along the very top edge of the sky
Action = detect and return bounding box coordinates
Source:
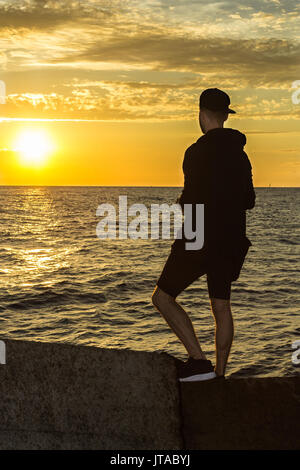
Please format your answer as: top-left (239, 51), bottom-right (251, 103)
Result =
top-left (0, 0), bottom-right (300, 38)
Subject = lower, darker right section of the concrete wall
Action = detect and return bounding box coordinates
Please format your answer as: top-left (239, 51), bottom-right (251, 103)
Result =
top-left (180, 375), bottom-right (300, 450)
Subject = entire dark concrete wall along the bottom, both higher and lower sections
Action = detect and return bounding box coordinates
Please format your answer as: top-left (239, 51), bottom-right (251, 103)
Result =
top-left (0, 340), bottom-right (300, 450)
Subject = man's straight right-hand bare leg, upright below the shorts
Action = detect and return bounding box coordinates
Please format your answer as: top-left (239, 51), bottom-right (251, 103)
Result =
top-left (210, 298), bottom-right (234, 375)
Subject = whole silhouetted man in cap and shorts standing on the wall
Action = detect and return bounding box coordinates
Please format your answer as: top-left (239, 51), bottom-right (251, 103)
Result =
top-left (152, 88), bottom-right (255, 382)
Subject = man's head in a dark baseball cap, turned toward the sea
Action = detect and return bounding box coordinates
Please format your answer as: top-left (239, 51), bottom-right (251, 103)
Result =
top-left (199, 88), bottom-right (235, 134)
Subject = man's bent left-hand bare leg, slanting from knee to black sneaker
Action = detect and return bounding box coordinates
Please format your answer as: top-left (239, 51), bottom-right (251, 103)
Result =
top-left (152, 286), bottom-right (206, 359)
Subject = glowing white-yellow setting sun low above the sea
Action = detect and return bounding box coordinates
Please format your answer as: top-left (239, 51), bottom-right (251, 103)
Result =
top-left (16, 131), bottom-right (53, 166)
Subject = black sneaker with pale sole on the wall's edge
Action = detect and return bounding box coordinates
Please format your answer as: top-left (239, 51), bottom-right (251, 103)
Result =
top-left (177, 357), bottom-right (217, 382)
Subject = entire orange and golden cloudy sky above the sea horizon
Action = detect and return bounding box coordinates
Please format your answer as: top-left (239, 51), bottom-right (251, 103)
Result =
top-left (0, 0), bottom-right (300, 186)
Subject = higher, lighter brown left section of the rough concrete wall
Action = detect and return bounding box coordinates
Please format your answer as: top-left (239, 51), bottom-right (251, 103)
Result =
top-left (0, 340), bottom-right (183, 450)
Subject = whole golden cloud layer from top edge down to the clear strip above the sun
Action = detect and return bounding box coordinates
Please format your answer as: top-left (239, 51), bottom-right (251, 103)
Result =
top-left (0, 0), bottom-right (300, 119)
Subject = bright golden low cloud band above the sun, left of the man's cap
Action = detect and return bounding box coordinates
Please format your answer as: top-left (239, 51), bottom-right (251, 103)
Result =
top-left (0, 82), bottom-right (194, 120)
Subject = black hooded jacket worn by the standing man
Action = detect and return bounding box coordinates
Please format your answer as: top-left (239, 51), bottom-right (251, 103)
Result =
top-left (177, 128), bottom-right (255, 253)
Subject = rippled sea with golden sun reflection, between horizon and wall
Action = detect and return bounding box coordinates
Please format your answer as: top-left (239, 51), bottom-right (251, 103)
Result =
top-left (0, 186), bottom-right (300, 377)
